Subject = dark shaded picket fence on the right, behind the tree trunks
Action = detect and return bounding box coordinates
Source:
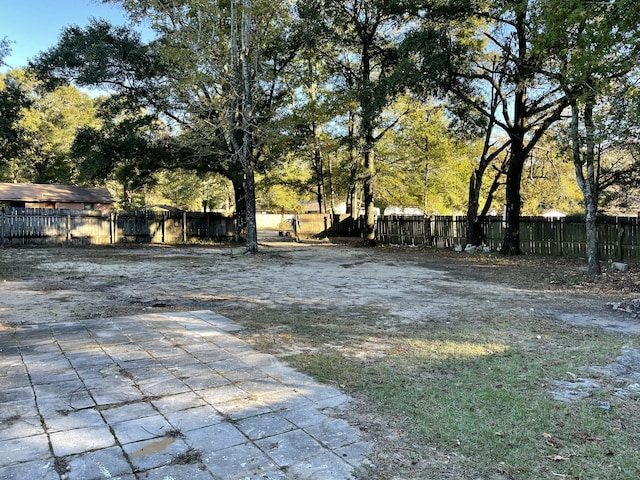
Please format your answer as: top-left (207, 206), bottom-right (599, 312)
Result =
top-left (377, 216), bottom-right (640, 262)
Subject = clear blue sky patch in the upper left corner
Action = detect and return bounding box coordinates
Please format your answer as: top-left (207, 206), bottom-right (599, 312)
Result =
top-left (0, 0), bottom-right (126, 68)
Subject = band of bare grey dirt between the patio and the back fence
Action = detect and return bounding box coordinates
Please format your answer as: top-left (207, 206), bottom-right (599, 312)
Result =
top-left (0, 241), bottom-right (640, 478)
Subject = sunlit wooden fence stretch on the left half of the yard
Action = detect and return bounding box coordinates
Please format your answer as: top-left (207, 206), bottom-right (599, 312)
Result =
top-left (0, 208), bottom-right (362, 245)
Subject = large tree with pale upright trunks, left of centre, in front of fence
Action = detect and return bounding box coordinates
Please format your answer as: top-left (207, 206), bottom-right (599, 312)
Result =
top-left (31, 0), bottom-right (298, 252)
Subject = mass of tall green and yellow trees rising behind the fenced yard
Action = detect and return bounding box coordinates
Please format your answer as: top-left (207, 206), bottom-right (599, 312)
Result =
top-left (0, 0), bottom-right (640, 262)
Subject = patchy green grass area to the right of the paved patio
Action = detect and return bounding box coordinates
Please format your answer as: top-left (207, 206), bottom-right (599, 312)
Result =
top-left (238, 311), bottom-right (640, 480)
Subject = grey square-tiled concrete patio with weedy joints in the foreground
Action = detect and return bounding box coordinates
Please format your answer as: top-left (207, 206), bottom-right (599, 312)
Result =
top-left (0, 311), bottom-right (370, 480)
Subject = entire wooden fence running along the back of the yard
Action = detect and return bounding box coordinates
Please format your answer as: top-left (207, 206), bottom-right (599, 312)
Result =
top-left (0, 208), bottom-right (640, 261)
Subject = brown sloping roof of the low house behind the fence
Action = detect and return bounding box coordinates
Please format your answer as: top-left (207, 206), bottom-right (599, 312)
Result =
top-left (0, 183), bottom-right (114, 203)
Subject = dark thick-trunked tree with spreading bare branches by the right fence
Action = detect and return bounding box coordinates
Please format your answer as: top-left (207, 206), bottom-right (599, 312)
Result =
top-left (410, 0), bottom-right (568, 255)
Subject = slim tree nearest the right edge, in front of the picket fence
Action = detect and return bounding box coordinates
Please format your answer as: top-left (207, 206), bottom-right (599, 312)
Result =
top-left (539, 0), bottom-right (640, 275)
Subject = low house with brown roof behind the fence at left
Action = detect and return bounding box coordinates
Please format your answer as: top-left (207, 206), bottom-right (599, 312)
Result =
top-left (0, 183), bottom-right (115, 210)
